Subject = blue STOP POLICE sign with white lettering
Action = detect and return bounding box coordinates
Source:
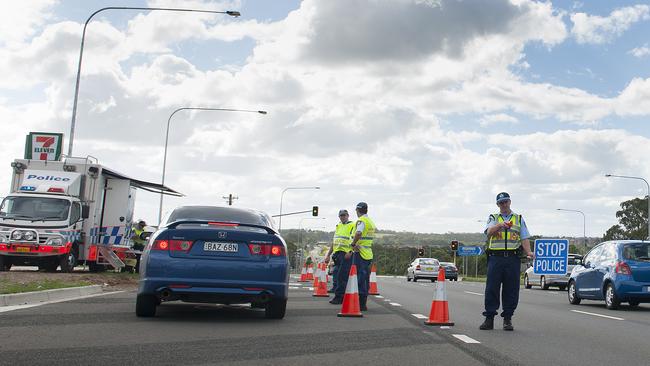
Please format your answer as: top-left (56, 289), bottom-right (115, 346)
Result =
top-left (533, 239), bottom-right (569, 275)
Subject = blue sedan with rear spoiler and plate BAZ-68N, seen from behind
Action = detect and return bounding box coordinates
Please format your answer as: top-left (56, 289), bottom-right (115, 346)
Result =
top-left (136, 206), bottom-right (289, 319)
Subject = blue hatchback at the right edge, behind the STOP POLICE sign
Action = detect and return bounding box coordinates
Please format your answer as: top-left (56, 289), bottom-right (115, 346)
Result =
top-left (568, 240), bottom-right (650, 309)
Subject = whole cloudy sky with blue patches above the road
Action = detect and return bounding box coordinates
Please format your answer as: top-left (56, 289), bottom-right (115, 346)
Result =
top-left (0, 0), bottom-right (650, 236)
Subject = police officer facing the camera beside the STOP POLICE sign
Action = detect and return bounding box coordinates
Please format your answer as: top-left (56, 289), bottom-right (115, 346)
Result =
top-left (479, 192), bottom-right (534, 330)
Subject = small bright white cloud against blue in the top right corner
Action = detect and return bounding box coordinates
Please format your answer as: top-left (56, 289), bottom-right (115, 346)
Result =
top-left (571, 5), bottom-right (650, 44)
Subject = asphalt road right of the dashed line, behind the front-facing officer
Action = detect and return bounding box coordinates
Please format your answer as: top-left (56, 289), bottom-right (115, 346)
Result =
top-left (379, 277), bottom-right (650, 366)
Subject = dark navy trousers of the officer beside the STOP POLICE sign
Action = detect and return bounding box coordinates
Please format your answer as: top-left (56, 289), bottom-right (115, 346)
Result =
top-left (483, 255), bottom-right (521, 318)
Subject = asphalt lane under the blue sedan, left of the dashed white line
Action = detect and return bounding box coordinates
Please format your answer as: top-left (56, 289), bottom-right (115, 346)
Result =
top-left (0, 281), bottom-right (515, 366)
